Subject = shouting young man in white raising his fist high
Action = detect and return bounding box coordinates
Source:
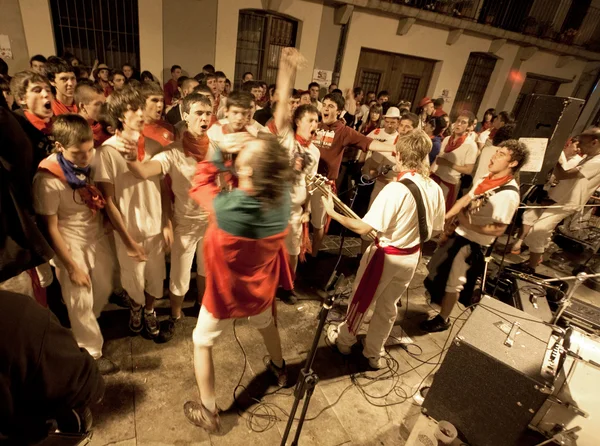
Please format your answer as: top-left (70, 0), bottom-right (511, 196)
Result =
top-left (269, 48), bottom-right (321, 304)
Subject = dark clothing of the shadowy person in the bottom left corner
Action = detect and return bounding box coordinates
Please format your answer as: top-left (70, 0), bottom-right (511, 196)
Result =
top-left (0, 291), bottom-right (104, 438)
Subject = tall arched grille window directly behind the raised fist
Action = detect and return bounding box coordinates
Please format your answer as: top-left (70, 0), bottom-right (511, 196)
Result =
top-left (235, 10), bottom-right (298, 85)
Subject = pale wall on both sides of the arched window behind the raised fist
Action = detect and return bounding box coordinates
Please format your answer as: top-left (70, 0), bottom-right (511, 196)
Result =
top-left (215, 0), bottom-right (324, 88)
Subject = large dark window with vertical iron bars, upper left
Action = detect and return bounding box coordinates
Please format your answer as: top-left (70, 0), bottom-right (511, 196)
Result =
top-left (50, 0), bottom-right (140, 68)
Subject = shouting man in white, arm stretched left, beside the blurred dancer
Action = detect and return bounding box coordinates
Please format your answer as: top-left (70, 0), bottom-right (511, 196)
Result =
top-left (113, 93), bottom-right (212, 342)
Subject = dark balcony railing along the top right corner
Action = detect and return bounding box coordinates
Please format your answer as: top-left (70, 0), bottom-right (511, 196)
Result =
top-left (386, 0), bottom-right (600, 51)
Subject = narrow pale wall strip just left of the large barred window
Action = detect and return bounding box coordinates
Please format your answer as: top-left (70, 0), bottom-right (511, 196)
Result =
top-left (17, 0), bottom-right (56, 57)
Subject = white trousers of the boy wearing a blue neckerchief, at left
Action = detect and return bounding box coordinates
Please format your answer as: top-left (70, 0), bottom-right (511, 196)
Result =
top-left (53, 243), bottom-right (108, 359)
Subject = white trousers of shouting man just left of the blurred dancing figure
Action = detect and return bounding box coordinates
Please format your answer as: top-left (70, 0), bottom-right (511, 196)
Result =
top-left (169, 221), bottom-right (207, 296)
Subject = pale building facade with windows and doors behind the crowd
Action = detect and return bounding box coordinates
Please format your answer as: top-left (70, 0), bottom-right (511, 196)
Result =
top-left (0, 0), bottom-right (600, 130)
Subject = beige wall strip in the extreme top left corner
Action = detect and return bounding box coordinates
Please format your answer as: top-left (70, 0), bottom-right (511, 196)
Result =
top-left (0, 0), bottom-right (29, 75)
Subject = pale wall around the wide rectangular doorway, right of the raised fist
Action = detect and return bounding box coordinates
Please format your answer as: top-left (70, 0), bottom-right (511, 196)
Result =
top-left (340, 10), bottom-right (490, 110)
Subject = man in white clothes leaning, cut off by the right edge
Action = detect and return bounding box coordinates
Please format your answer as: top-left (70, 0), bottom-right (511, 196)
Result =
top-left (525, 127), bottom-right (600, 270)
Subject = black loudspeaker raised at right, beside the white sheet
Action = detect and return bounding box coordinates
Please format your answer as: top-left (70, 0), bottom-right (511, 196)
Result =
top-left (513, 94), bottom-right (585, 184)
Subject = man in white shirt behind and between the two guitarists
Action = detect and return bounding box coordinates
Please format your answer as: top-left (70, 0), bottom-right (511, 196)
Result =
top-left (431, 110), bottom-right (477, 211)
